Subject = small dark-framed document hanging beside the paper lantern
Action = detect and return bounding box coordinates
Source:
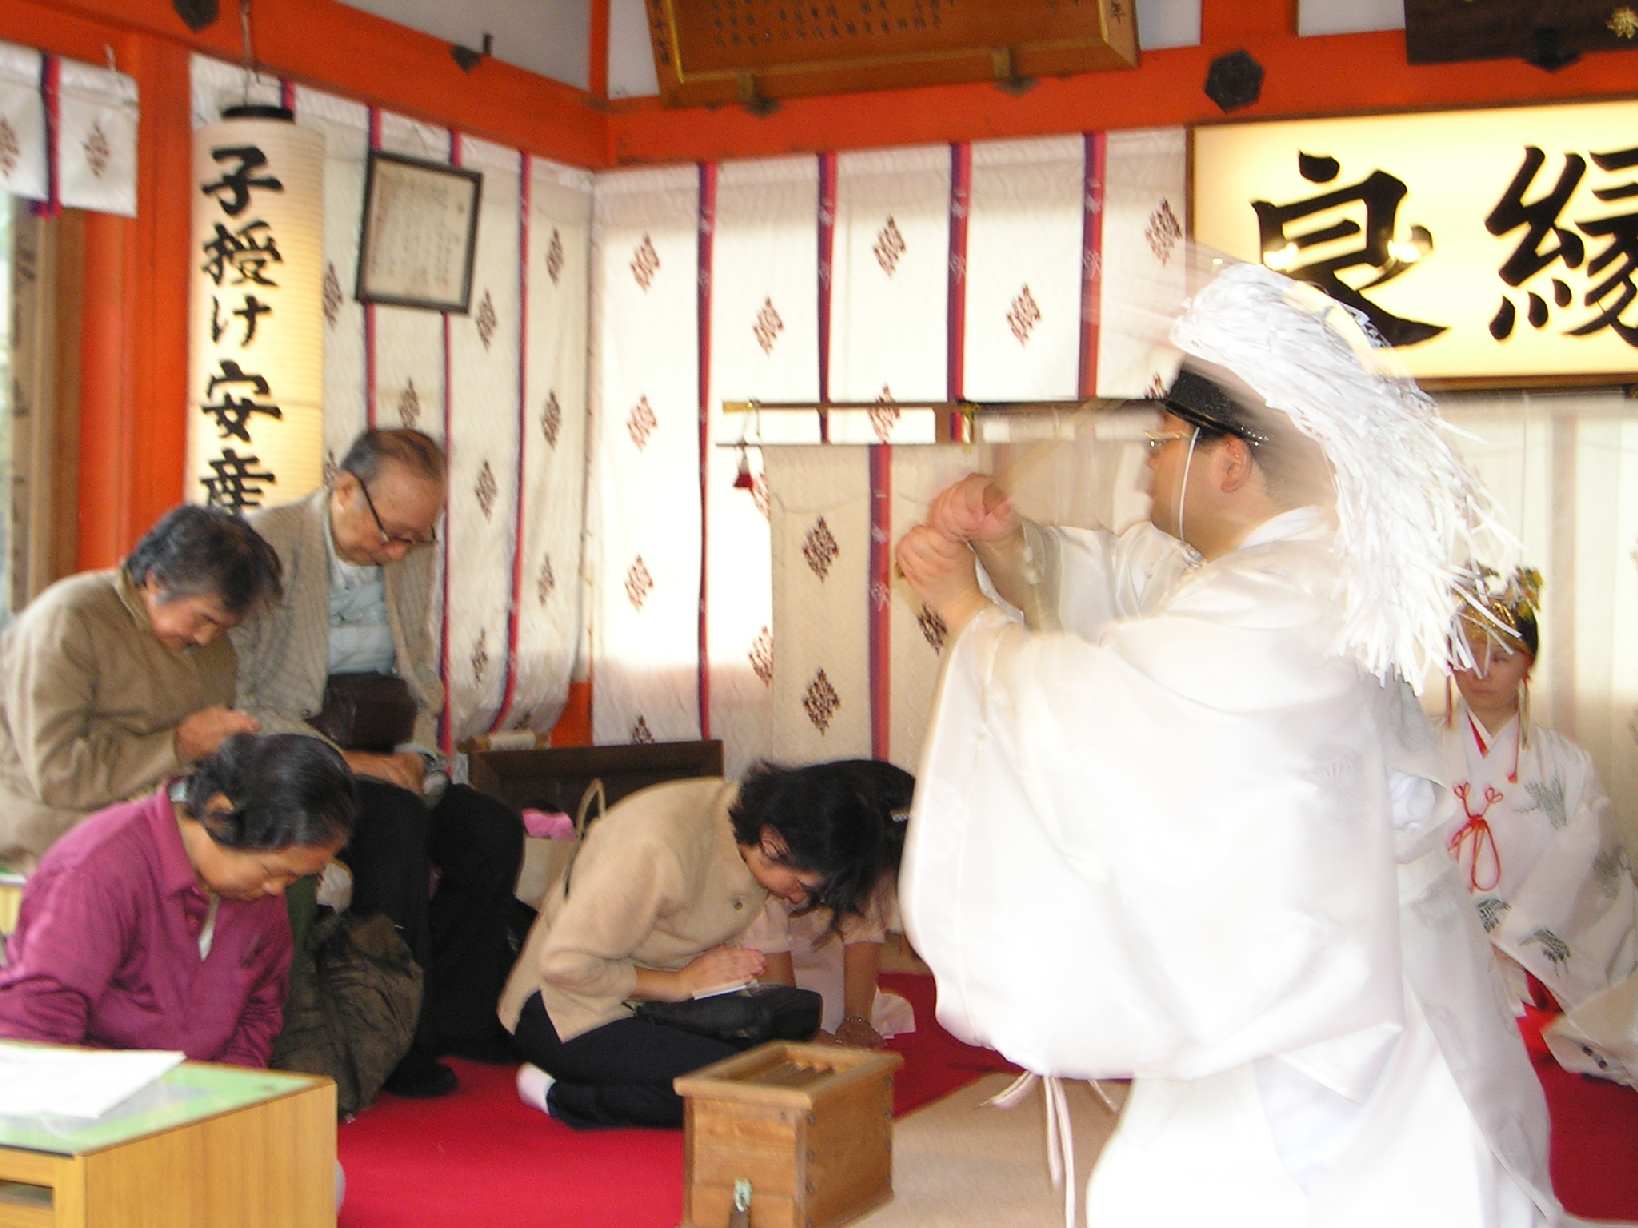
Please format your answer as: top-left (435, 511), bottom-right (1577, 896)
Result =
top-left (354, 149), bottom-right (483, 316)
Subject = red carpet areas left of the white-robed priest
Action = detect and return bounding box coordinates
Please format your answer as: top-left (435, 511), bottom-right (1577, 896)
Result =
top-left (336, 974), bottom-right (1012, 1228)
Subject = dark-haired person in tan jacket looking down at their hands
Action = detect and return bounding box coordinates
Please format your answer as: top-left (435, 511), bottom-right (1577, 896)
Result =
top-left (0, 506), bottom-right (280, 871)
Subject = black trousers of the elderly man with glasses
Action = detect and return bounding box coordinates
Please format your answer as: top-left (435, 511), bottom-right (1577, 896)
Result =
top-left (341, 776), bottom-right (523, 1051)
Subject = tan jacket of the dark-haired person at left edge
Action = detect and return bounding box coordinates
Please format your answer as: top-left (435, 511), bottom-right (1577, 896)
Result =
top-left (0, 568), bottom-right (234, 871)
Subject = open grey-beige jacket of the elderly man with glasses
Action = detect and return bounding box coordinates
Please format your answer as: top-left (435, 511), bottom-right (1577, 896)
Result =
top-left (233, 488), bottom-right (444, 748)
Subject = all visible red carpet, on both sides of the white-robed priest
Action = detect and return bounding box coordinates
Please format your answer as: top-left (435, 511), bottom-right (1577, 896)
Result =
top-left (337, 974), bottom-right (1638, 1228)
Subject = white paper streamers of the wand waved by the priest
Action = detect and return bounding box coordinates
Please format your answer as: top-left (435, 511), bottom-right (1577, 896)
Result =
top-left (1171, 259), bottom-right (1505, 689)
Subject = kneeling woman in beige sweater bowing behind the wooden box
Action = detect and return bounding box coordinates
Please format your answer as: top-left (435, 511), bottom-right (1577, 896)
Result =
top-left (500, 763), bottom-right (885, 1126)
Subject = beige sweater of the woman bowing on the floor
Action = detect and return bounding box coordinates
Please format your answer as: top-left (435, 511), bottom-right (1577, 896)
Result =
top-left (500, 776), bottom-right (768, 1041)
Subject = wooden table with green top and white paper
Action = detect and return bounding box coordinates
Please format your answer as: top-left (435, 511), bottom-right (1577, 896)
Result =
top-left (0, 1063), bottom-right (336, 1228)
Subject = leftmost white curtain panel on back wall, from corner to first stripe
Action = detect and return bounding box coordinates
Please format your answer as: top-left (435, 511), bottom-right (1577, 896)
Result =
top-left (591, 167), bottom-right (701, 743)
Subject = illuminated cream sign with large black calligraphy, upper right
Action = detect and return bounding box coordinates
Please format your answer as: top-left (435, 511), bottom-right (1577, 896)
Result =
top-left (1191, 100), bottom-right (1638, 388)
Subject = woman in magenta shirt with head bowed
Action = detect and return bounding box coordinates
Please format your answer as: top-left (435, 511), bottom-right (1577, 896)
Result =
top-left (0, 734), bottom-right (357, 1066)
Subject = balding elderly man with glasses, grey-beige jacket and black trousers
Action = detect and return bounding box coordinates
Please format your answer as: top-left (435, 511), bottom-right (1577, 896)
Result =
top-left (234, 431), bottom-right (523, 1095)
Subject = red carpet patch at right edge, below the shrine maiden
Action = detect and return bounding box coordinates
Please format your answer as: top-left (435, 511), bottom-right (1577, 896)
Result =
top-left (1518, 1010), bottom-right (1638, 1220)
